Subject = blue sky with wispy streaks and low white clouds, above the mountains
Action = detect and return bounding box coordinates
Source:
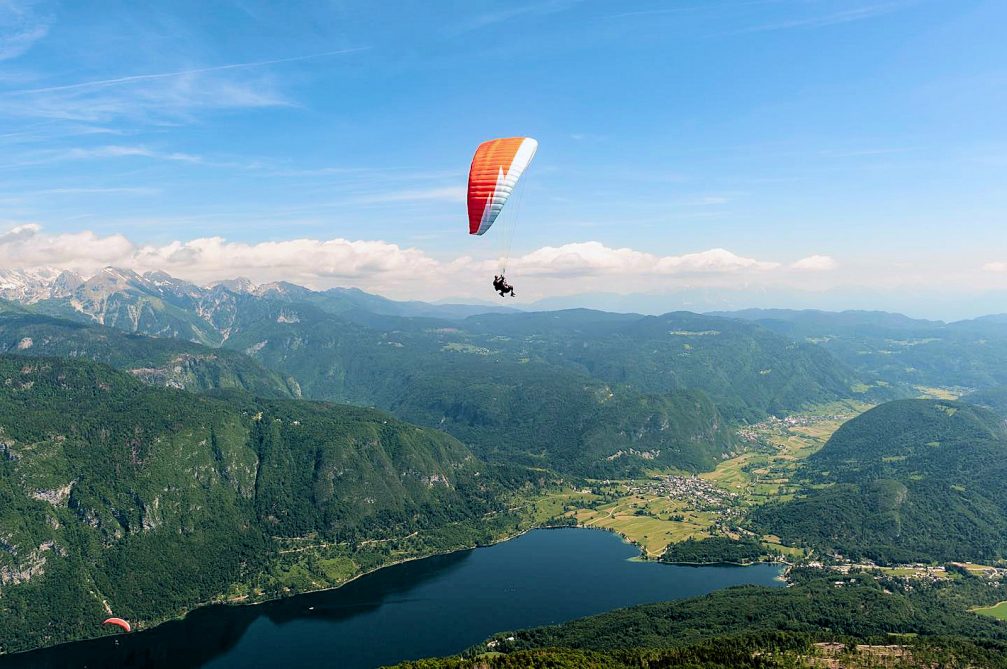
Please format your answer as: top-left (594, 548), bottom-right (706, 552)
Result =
top-left (0, 0), bottom-right (1007, 316)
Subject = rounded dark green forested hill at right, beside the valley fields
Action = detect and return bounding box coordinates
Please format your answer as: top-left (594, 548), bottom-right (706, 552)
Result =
top-left (755, 400), bottom-right (1007, 562)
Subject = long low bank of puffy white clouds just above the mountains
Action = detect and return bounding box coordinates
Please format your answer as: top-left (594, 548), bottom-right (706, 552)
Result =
top-left (0, 224), bottom-right (841, 299)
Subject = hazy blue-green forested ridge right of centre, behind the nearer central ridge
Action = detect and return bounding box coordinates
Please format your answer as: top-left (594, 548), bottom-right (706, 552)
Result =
top-left (464, 309), bottom-right (857, 419)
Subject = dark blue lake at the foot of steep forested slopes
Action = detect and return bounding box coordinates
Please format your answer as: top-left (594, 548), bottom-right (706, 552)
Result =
top-left (0, 528), bottom-right (781, 669)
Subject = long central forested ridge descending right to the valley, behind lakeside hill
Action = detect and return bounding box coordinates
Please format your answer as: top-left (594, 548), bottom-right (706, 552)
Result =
top-left (214, 302), bottom-right (734, 476)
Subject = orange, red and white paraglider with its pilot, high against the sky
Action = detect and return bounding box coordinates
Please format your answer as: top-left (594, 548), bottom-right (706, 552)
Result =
top-left (468, 137), bottom-right (539, 297)
